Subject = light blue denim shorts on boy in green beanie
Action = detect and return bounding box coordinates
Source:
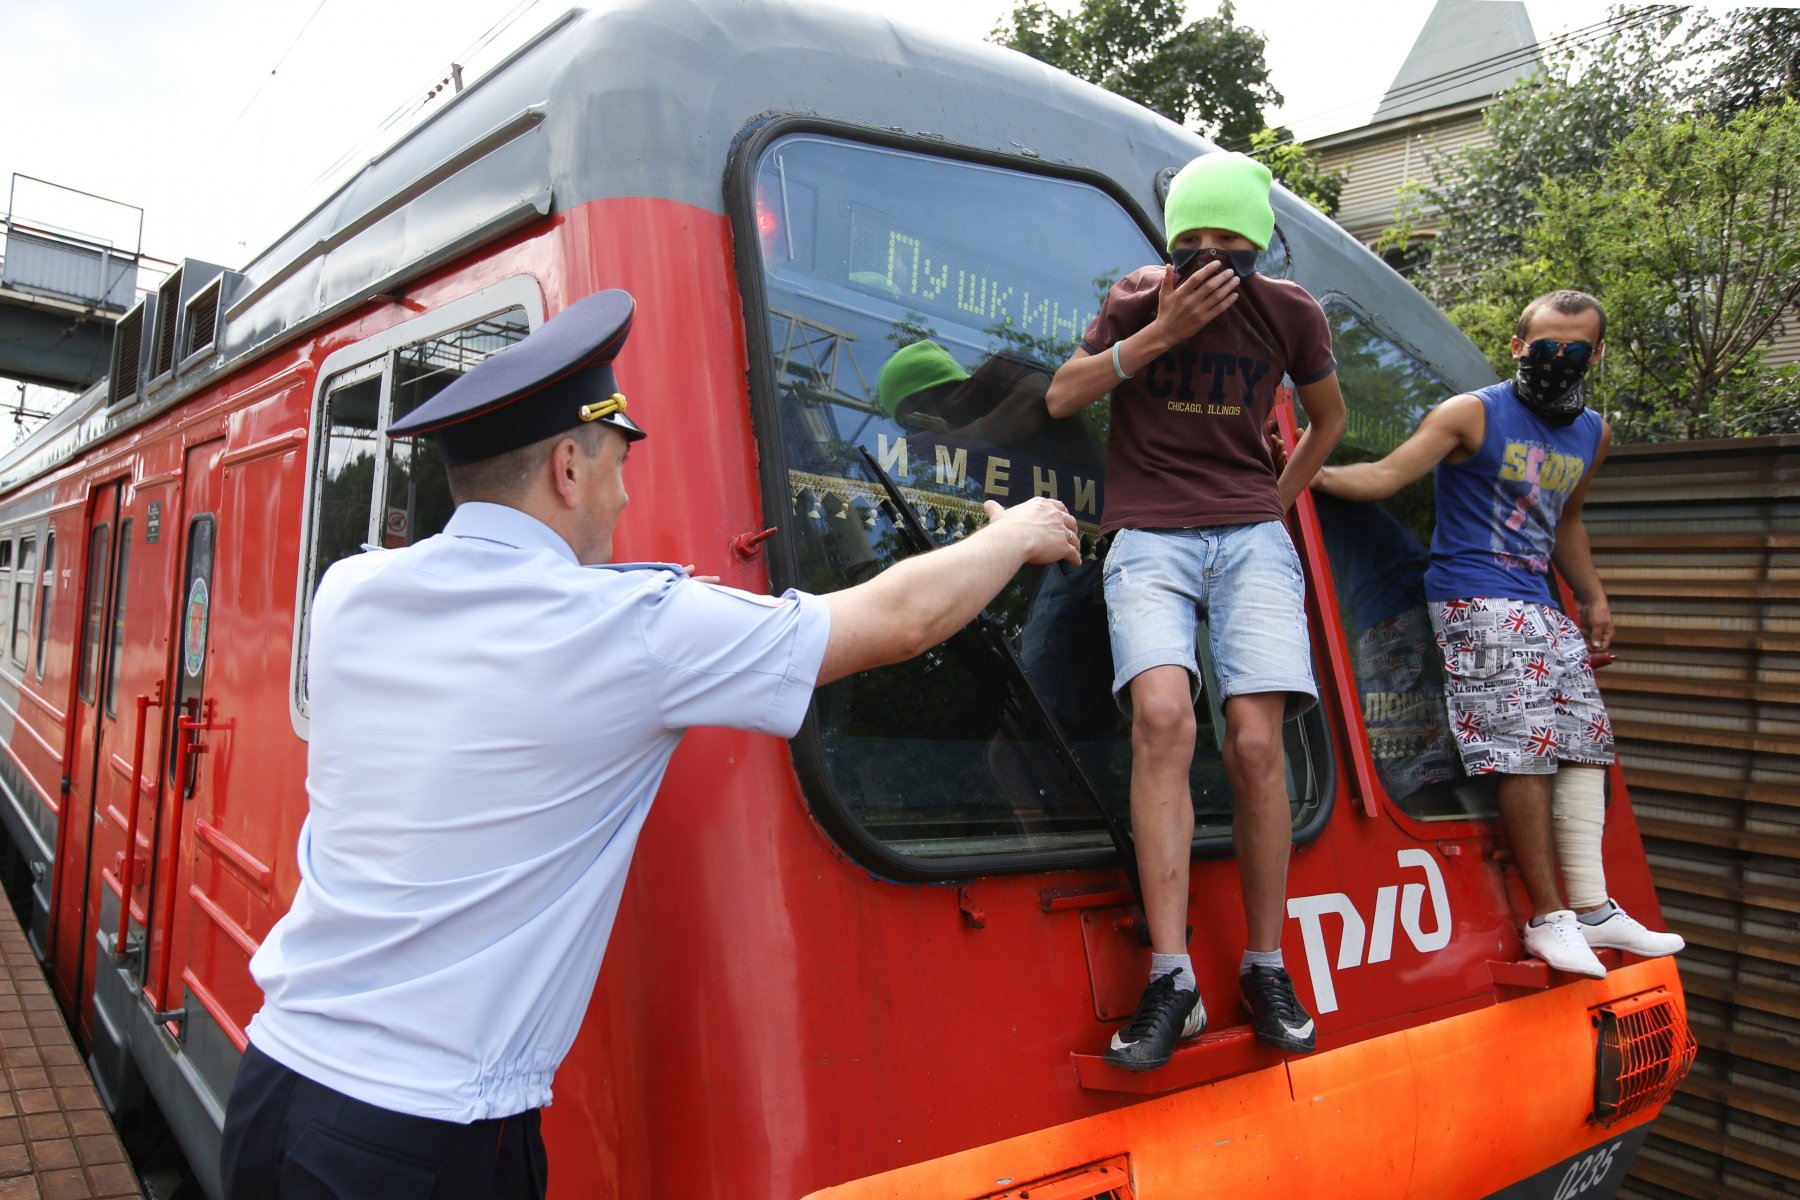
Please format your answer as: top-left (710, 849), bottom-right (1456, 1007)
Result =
top-left (1105, 522), bottom-right (1319, 718)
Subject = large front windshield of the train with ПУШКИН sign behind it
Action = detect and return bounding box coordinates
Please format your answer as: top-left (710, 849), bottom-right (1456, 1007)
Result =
top-left (751, 133), bottom-right (1330, 878)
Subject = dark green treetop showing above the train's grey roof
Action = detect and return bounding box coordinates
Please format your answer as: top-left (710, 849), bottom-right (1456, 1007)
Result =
top-left (988, 0), bottom-right (1282, 146)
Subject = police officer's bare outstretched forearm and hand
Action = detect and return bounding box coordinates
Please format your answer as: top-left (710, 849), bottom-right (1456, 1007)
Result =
top-left (819, 497), bottom-right (1082, 684)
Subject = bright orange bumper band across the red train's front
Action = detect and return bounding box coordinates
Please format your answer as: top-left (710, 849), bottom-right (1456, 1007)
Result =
top-left (806, 959), bottom-right (1687, 1200)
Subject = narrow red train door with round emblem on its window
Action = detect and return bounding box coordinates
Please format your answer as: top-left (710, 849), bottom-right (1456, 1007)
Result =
top-left (142, 439), bottom-right (225, 1029)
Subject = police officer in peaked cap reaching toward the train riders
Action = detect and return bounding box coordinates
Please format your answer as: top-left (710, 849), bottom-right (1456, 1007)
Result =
top-left (221, 291), bottom-right (1078, 1200)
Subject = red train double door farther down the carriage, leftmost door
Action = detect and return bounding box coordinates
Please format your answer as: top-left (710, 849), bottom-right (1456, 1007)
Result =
top-left (49, 480), bottom-right (126, 1016)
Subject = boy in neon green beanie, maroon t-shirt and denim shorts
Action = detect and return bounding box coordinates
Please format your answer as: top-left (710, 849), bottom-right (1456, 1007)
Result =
top-left (1046, 153), bottom-right (1345, 1070)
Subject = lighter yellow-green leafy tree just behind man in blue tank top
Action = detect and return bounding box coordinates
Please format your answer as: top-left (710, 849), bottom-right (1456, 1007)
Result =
top-left (1512, 101), bottom-right (1800, 439)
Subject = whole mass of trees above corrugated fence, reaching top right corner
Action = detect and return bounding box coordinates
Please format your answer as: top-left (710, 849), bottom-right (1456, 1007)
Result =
top-left (1381, 7), bottom-right (1800, 441)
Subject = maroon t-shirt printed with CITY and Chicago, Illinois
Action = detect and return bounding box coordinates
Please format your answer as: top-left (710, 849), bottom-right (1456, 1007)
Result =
top-left (1082, 264), bottom-right (1337, 533)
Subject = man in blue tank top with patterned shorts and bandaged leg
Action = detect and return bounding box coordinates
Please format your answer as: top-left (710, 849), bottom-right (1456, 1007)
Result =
top-left (1312, 291), bottom-right (1683, 979)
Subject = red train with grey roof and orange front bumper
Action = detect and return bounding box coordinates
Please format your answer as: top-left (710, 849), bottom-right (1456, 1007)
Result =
top-left (0, 0), bottom-right (1692, 1200)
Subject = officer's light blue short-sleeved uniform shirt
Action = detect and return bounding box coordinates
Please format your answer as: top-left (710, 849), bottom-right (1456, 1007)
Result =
top-left (250, 504), bottom-right (830, 1121)
